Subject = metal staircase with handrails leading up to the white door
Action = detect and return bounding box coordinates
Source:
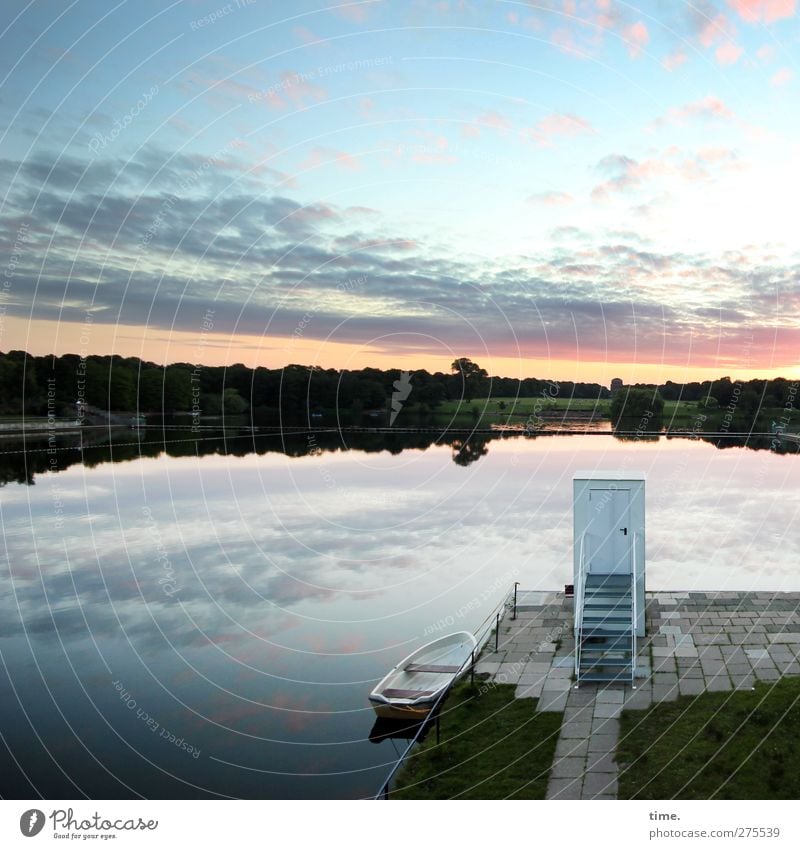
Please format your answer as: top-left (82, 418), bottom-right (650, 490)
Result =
top-left (575, 534), bottom-right (637, 683)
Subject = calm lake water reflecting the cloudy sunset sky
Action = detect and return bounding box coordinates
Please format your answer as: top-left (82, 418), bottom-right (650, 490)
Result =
top-left (0, 436), bottom-right (800, 798)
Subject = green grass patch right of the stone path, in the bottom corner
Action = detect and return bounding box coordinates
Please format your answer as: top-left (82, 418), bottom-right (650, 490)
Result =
top-left (617, 678), bottom-right (800, 799)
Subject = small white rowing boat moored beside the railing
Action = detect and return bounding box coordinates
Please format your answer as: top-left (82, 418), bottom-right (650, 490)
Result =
top-left (369, 631), bottom-right (477, 719)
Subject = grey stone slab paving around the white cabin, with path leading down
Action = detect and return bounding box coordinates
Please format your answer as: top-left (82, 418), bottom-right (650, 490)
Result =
top-left (476, 592), bottom-right (800, 799)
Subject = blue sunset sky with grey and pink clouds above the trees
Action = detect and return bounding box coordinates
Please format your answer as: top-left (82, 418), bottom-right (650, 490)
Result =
top-left (0, 0), bottom-right (800, 384)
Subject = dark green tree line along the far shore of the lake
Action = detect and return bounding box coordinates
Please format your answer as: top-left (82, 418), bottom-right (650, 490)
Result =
top-left (0, 351), bottom-right (797, 421)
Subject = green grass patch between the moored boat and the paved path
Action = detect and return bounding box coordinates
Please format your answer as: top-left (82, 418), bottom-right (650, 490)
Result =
top-left (392, 679), bottom-right (562, 799)
